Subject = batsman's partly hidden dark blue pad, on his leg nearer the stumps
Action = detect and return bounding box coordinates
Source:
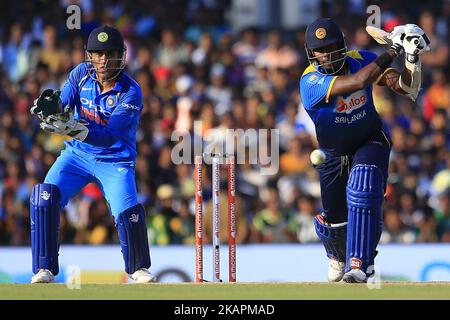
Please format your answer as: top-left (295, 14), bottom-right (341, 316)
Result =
top-left (314, 215), bottom-right (347, 262)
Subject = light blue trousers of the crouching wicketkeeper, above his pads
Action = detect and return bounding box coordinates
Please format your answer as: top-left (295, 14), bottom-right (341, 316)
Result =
top-left (44, 148), bottom-right (138, 221)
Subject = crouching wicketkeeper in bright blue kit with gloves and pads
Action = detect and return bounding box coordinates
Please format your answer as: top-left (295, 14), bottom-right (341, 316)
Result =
top-left (30, 26), bottom-right (153, 283)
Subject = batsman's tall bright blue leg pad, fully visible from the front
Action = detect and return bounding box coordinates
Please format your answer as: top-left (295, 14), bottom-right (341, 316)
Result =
top-left (346, 165), bottom-right (384, 272)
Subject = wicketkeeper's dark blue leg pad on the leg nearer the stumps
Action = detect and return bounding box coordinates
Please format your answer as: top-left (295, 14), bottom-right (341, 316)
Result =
top-left (117, 204), bottom-right (150, 274)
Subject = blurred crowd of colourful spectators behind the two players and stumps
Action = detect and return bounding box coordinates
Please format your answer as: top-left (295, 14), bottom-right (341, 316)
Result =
top-left (0, 0), bottom-right (450, 282)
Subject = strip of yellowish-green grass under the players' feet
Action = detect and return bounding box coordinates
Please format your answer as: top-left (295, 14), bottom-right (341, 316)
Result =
top-left (0, 282), bottom-right (450, 300)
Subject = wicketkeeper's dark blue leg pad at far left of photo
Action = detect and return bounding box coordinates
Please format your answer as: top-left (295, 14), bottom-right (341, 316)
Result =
top-left (30, 183), bottom-right (61, 275)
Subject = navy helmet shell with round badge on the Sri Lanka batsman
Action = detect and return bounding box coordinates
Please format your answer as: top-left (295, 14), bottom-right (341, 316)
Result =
top-left (305, 18), bottom-right (344, 50)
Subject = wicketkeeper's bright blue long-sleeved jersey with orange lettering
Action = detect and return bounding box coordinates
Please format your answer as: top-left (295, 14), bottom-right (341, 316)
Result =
top-left (61, 63), bottom-right (142, 162)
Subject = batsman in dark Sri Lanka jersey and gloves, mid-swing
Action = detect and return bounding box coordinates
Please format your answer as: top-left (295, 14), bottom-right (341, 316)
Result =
top-left (300, 19), bottom-right (429, 283)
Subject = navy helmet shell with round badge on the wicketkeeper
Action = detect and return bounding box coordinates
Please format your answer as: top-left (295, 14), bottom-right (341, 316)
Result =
top-left (86, 26), bottom-right (125, 51)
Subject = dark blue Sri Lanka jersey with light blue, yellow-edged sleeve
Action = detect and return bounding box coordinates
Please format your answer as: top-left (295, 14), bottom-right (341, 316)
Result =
top-left (300, 50), bottom-right (382, 156)
